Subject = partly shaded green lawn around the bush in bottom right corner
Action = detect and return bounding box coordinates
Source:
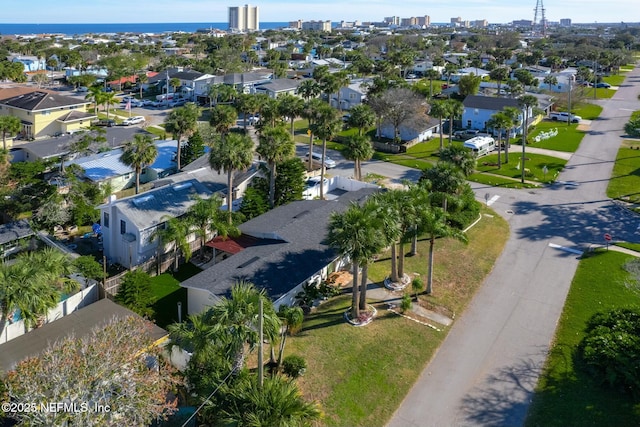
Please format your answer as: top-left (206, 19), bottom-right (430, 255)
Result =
top-left (525, 251), bottom-right (640, 427)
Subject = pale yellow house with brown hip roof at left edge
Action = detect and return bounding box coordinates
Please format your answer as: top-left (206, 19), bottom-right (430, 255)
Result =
top-left (0, 90), bottom-right (96, 139)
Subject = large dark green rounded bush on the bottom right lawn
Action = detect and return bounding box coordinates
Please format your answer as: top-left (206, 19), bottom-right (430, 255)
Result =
top-left (578, 308), bottom-right (640, 396)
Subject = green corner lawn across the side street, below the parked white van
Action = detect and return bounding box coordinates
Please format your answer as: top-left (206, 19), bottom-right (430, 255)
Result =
top-left (476, 153), bottom-right (567, 183)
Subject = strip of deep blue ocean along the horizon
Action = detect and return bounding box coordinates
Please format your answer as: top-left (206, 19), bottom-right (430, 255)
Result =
top-left (0, 22), bottom-right (296, 36)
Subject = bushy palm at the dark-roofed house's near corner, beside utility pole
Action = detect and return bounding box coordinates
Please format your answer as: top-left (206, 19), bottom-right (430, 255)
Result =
top-left (206, 282), bottom-right (280, 372)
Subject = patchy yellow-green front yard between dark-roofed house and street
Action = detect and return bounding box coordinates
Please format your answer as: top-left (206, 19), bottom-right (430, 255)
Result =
top-left (285, 207), bottom-right (509, 427)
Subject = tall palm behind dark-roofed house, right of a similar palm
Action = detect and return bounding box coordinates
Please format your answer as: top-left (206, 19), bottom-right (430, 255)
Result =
top-left (256, 126), bottom-right (296, 208)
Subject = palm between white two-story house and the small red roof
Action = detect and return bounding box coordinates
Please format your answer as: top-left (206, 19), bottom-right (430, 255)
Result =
top-left (187, 194), bottom-right (240, 259)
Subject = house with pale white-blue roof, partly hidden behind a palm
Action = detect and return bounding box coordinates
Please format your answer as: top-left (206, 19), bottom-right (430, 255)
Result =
top-left (65, 140), bottom-right (178, 192)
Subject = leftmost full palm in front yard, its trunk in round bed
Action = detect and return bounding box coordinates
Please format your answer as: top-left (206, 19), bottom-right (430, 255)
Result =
top-left (327, 201), bottom-right (386, 320)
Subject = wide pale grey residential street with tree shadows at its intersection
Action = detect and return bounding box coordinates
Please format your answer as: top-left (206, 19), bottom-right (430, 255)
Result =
top-left (389, 68), bottom-right (640, 427)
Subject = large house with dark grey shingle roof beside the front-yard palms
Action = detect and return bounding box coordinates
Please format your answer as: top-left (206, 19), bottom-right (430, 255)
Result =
top-left (180, 188), bottom-right (378, 314)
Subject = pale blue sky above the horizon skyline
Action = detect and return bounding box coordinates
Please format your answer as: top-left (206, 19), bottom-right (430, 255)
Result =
top-left (0, 0), bottom-right (640, 23)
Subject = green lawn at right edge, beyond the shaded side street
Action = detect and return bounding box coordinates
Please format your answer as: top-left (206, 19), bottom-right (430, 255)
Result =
top-left (607, 140), bottom-right (640, 203)
